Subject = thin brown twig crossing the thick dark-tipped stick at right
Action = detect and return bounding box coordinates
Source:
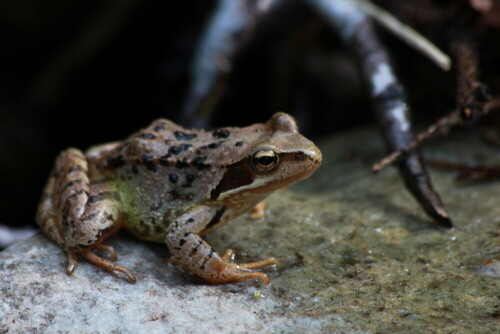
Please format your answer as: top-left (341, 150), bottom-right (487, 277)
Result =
top-left (372, 98), bottom-right (500, 173)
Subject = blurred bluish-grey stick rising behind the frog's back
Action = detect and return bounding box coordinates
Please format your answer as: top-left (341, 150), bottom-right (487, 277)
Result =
top-left (181, 0), bottom-right (280, 127)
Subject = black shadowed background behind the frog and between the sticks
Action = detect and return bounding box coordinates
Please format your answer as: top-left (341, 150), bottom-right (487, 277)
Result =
top-left (0, 0), bottom-right (492, 226)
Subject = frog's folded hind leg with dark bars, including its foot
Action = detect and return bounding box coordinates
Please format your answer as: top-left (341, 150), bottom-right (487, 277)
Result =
top-left (37, 148), bottom-right (135, 282)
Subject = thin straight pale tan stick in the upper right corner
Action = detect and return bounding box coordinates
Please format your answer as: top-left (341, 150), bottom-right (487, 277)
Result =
top-left (352, 0), bottom-right (451, 71)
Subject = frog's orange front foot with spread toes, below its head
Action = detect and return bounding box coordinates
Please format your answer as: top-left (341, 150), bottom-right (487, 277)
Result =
top-left (213, 249), bottom-right (279, 285)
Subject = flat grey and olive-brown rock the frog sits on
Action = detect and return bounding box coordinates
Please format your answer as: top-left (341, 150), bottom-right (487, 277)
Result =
top-left (0, 129), bottom-right (500, 333)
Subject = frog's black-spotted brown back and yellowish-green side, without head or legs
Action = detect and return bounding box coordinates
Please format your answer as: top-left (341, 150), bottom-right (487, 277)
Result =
top-left (91, 119), bottom-right (265, 242)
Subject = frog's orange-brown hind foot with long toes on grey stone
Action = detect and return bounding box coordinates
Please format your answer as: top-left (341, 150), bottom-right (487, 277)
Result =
top-left (66, 244), bottom-right (136, 283)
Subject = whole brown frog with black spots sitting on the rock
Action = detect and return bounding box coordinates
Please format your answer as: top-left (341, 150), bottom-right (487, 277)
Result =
top-left (36, 112), bottom-right (322, 284)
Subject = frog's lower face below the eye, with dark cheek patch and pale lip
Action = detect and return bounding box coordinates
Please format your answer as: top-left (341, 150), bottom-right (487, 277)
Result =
top-left (210, 149), bottom-right (321, 200)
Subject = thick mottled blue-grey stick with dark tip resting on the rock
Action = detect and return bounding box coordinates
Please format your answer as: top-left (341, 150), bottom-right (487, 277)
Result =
top-left (307, 0), bottom-right (453, 227)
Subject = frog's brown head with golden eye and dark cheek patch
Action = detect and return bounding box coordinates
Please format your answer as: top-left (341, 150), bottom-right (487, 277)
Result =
top-left (212, 112), bottom-right (322, 199)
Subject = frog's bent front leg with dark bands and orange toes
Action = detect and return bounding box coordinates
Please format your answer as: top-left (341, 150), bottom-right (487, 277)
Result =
top-left (165, 205), bottom-right (279, 284)
